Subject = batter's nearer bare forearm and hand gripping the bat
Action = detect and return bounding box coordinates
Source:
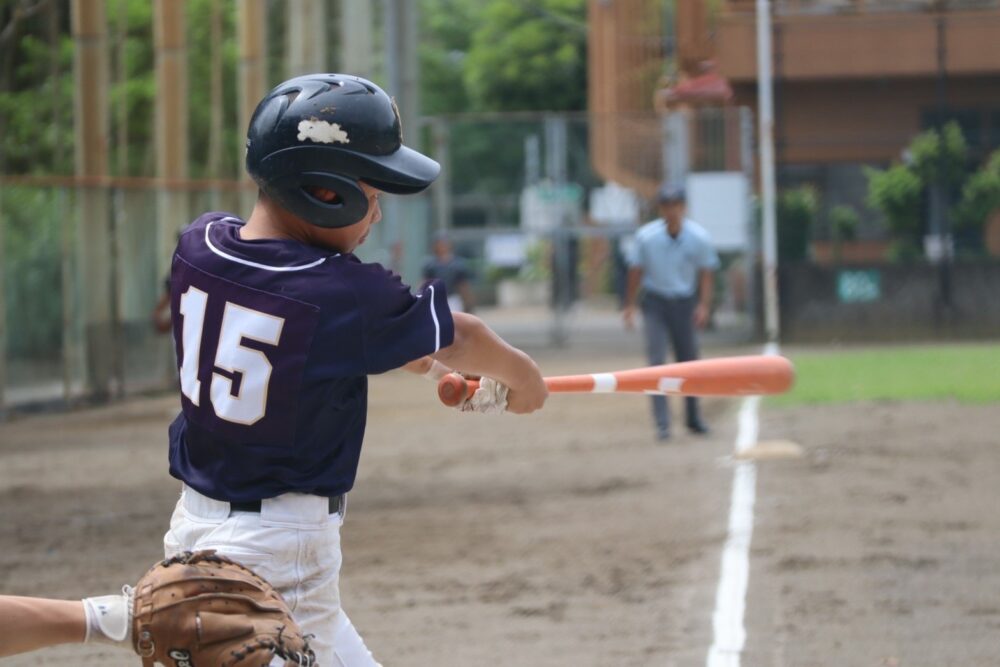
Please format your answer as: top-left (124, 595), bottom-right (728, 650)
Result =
top-left (436, 313), bottom-right (549, 414)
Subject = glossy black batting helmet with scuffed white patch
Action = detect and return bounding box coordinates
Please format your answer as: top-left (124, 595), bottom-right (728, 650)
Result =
top-left (246, 74), bottom-right (441, 227)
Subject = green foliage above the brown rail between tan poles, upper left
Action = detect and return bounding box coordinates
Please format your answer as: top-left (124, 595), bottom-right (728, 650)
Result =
top-left (0, 0), bottom-right (244, 178)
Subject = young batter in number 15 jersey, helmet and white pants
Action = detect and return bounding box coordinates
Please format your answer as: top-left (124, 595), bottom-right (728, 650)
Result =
top-left (158, 74), bottom-right (547, 667)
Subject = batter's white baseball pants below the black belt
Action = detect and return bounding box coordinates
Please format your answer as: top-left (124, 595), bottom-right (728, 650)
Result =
top-left (163, 486), bottom-right (380, 667)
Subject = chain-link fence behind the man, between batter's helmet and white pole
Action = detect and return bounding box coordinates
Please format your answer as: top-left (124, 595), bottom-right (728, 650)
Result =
top-left (429, 108), bottom-right (756, 345)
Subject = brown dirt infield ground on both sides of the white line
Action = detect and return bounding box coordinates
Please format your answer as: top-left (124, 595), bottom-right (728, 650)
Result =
top-left (0, 353), bottom-right (1000, 667)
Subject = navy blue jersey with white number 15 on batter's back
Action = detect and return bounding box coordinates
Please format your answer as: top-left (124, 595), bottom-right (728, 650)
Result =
top-left (170, 213), bottom-right (454, 501)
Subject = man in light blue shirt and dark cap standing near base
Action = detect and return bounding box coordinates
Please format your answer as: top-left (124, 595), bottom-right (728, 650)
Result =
top-left (623, 184), bottom-right (719, 441)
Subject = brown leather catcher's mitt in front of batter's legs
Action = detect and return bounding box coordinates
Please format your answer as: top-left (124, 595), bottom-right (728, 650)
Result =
top-left (132, 551), bottom-right (316, 667)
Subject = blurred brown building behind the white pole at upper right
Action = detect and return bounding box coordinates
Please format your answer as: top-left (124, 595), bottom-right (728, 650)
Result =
top-left (590, 0), bottom-right (1000, 223)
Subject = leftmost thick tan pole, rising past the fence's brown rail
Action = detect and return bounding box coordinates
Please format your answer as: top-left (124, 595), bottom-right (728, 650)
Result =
top-left (71, 0), bottom-right (114, 400)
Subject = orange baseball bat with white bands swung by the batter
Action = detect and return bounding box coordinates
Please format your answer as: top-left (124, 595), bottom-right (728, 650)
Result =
top-left (438, 355), bottom-right (795, 407)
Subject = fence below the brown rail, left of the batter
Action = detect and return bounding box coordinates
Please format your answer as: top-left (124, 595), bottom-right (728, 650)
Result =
top-left (0, 177), bottom-right (248, 411)
